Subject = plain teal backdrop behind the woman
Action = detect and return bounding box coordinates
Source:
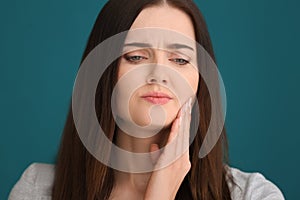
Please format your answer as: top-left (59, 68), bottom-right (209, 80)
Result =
top-left (0, 0), bottom-right (300, 199)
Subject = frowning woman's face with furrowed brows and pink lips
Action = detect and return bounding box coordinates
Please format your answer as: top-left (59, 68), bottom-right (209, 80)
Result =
top-left (118, 5), bottom-right (199, 129)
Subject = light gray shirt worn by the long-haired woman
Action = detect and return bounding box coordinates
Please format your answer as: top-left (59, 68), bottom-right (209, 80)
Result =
top-left (9, 163), bottom-right (284, 200)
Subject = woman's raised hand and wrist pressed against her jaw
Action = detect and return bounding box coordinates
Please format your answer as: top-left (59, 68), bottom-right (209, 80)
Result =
top-left (144, 98), bottom-right (192, 200)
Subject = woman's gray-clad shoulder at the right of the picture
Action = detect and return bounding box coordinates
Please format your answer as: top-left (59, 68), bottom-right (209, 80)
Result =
top-left (227, 166), bottom-right (284, 200)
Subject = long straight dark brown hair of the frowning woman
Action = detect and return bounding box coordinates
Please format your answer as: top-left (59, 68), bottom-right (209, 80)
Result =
top-left (52, 0), bottom-right (232, 200)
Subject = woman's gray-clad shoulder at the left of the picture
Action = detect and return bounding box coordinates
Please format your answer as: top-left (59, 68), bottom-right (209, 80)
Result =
top-left (8, 163), bottom-right (55, 200)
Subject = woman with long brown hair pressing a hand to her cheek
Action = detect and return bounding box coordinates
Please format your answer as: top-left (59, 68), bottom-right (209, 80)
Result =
top-left (10, 0), bottom-right (284, 200)
